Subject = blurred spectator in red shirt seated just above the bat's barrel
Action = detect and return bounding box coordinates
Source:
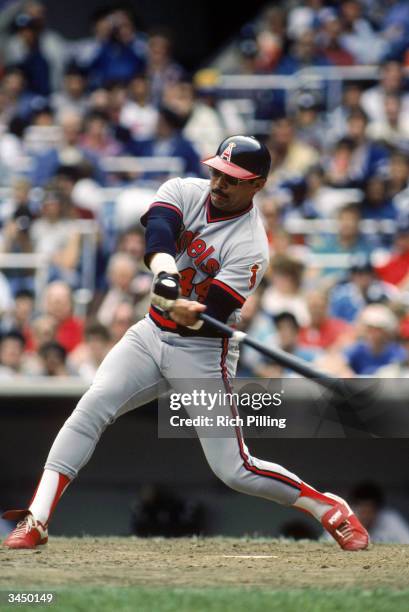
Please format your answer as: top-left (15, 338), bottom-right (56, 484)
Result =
top-left (299, 290), bottom-right (354, 349)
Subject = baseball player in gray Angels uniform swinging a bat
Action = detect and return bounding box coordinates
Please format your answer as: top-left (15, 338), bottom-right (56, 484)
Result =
top-left (4, 136), bottom-right (368, 550)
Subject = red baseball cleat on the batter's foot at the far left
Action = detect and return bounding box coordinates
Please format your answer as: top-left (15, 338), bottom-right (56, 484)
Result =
top-left (3, 510), bottom-right (48, 548)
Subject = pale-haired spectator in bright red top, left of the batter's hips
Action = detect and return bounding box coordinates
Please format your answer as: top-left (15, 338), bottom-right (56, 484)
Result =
top-left (44, 281), bottom-right (84, 353)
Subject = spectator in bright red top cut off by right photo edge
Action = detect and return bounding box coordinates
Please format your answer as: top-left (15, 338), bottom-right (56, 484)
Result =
top-left (376, 217), bottom-right (409, 290)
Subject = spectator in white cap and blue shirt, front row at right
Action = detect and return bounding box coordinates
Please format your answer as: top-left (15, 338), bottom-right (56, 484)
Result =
top-left (345, 304), bottom-right (408, 376)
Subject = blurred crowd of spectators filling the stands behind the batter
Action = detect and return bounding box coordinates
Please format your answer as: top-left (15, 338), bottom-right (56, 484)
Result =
top-left (0, 0), bottom-right (409, 382)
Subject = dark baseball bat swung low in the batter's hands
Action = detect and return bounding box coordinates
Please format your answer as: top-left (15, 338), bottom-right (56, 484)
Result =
top-left (199, 312), bottom-right (344, 395)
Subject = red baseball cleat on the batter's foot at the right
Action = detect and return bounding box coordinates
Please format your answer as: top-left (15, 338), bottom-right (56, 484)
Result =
top-left (321, 493), bottom-right (369, 550)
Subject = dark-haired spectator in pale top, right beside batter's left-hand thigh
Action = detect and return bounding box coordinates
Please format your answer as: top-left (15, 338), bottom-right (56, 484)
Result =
top-left (68, 321), bottom-right (111, 384)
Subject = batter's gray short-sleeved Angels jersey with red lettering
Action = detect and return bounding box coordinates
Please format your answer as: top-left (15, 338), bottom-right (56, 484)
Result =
top-left (145, 178), bottom-right (269, 328)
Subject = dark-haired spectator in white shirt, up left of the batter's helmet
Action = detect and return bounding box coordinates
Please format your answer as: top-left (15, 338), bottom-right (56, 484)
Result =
top-left (119, 73), bottom-right (158, 140)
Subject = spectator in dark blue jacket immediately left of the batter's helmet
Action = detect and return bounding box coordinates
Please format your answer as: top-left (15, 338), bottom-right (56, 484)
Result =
top-left (130, 105), bottom-right (203, 180)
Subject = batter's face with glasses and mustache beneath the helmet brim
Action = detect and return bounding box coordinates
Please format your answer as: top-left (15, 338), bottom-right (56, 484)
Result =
top-left (210, 168), bottom-right (265, 212)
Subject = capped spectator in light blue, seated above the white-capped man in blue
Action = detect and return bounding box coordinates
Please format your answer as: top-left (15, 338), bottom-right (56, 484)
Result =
top-left (329, 255), bottom-right (401, 323)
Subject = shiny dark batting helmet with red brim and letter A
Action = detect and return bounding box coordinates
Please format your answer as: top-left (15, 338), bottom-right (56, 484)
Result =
top-left (202, 136), bottom-right (271, 180)
